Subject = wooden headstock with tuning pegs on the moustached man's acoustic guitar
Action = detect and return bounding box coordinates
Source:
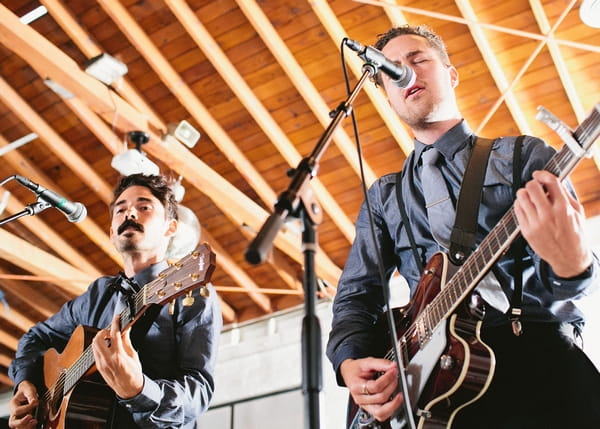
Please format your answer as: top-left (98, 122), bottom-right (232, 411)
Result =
top-left (140, 243), bottom-right (216, 305)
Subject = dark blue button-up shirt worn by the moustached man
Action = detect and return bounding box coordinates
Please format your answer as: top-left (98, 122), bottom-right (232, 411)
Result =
top-left (9, 262), bottom-right (222, 429)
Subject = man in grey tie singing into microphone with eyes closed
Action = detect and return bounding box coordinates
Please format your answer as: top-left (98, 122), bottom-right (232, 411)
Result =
top-left (327, 26), bottom-right (600, 429)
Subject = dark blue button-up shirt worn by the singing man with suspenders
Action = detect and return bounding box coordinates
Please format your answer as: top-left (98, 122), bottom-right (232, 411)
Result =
top-left (327, 121), bottom-right (600, 378)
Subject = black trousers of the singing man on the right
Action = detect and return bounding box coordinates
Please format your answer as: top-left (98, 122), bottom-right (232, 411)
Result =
top-left (452, 323), bottom-right (600, 429)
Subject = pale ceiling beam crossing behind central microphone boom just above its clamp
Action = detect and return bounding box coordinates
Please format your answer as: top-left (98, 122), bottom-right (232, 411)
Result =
top-left (166, 0), bottom-right (355, 243)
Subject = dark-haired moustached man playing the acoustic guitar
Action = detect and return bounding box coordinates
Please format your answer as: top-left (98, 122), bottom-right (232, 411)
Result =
top-left (9, 174), bottom-right (222, 429)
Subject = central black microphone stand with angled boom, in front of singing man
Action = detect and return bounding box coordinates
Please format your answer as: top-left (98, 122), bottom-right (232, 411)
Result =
top-left (245, 63), bottom-right (386, 429)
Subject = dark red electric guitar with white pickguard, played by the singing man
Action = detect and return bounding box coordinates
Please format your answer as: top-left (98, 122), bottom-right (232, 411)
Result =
top-left (348, 104), bottom-right (600, 429)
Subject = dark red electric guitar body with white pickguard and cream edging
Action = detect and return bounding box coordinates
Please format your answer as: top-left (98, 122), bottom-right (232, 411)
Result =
top-left (349, 253), bottom-right (495, 429)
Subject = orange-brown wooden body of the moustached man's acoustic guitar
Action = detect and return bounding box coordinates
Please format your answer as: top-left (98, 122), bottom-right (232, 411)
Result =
top-left (36, 326), bottom-right (114, 429)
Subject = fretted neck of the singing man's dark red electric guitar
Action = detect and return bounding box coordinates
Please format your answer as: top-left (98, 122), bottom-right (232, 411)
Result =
top-left (415, 105), bottom-right (600, 330)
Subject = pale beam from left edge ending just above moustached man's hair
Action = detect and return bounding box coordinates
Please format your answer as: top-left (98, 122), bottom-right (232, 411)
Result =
top-left (0, 75), bottom-right (112, 204)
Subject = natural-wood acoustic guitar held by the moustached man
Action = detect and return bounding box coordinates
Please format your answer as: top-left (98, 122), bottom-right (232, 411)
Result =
top-left (36, 244), bottom-right (216, 429)
